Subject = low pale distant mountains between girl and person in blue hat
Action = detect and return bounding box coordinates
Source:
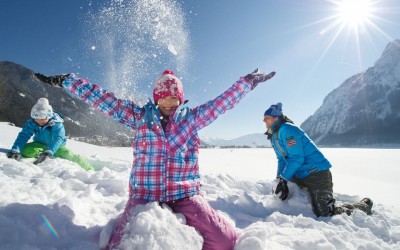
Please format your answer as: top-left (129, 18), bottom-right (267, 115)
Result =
top-left (201, 133), bottom-right (271, 147)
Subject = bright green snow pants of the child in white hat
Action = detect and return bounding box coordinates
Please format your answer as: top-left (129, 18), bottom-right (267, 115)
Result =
top-left (21, 142), bottom-right (94, 170)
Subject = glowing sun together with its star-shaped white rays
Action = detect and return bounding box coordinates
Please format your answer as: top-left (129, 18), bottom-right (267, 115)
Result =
top-left (303, 0), bottom-right (397, 75)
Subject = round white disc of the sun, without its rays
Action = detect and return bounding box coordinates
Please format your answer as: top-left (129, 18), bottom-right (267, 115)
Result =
top-left (336, 0), bottom-right (373, 28)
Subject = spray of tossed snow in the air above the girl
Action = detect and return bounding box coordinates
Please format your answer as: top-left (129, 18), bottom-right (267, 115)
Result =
top-left (85, 0), bottom-right (190, 99)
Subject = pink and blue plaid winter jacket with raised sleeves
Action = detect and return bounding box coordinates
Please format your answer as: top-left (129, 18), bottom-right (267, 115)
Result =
top-left (63, 74), bottom-right (251, 202)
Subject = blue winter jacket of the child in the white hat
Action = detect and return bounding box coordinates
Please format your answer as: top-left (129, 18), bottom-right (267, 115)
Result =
top-left (11, 113), bottom-right (66, 155)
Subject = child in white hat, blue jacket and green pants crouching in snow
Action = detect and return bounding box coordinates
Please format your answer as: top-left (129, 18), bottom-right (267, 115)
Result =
top-left (7, 98), bottom-right (93, 170)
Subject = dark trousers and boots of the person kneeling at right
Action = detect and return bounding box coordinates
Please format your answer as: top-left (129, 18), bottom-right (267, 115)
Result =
top-left (292, 170), bottom-right (371, 217)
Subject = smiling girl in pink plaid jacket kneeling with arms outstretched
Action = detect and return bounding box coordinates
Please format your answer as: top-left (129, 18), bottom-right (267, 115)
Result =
top-left (36, 70), bottom-right (275, 250)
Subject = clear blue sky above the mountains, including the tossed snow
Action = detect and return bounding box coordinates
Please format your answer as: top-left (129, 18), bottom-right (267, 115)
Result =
top-left (0, 0), bottom-right (400, 139)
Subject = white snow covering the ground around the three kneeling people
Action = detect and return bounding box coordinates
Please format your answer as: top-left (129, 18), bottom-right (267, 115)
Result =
top-left (0, 122), bottom-right (400, 250)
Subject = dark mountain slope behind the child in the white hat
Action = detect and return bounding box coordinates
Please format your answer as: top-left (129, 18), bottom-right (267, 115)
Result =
top-left (0, 62), bottom-right (133, 146)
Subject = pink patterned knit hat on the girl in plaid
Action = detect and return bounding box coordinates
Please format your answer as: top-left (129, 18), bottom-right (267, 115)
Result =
top-left (153, 69), bottom-right (183, 104)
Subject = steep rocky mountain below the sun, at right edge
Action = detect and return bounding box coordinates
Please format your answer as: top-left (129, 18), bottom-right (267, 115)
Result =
top-left (301, 40), bottom-right (400, 147)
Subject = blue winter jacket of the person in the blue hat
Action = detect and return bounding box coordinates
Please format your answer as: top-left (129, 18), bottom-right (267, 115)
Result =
top-left (270, 120), bottom-right (332, 180)
